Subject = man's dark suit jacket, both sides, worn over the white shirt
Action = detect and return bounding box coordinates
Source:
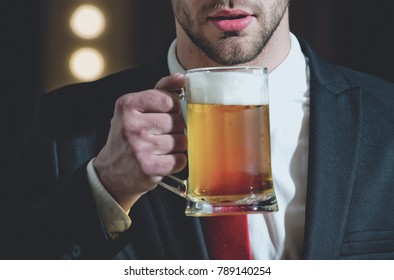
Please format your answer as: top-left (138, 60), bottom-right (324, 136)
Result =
top-left (3, 40), bottom-right (394, 259)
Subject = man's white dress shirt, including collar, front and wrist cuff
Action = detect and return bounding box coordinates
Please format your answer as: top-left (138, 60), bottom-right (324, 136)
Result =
top-left (87, 34), bottom-right (309, 259)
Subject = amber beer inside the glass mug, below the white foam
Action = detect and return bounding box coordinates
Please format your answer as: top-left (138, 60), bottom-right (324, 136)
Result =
top-left (187, 104), bottom-right (272, 203)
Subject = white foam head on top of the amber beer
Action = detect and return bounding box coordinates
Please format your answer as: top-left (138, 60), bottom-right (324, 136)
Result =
top-left (186, 72), bottom-right (268, 105)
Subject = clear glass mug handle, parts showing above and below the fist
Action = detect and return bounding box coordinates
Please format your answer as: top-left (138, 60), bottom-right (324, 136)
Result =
top-left (159, 88), bottom-right (187, 198)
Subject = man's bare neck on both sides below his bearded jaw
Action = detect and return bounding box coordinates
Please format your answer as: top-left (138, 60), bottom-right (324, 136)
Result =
top-left (176, 10), bottom-right (291, 72)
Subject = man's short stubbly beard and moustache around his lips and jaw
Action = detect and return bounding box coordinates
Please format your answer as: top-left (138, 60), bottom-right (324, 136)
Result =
top-left (173, 0), bottom-right (289, 66)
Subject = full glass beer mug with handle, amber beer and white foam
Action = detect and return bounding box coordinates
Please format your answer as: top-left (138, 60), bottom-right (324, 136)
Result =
top-left (160, 66), bottom-right (278, 216)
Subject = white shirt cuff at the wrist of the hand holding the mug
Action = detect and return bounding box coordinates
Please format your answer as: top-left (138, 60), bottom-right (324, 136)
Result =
top-left (86, 159), bottom-right (131, 238)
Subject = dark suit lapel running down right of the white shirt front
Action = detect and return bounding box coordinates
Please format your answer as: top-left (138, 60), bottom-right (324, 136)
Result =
top-left (302, 39), bottom-right (362, 259)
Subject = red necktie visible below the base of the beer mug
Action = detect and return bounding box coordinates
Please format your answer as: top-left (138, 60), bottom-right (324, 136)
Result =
top-left (201, 215), bottom-right (252, 260)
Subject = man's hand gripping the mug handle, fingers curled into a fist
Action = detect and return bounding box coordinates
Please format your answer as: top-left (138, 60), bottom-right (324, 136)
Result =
top-left (94, 74), bottom-right (187, 211)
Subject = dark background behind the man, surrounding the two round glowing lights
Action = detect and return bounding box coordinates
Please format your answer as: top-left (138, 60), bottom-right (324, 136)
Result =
top-left (0, 0), bottom-right (394, 190)
